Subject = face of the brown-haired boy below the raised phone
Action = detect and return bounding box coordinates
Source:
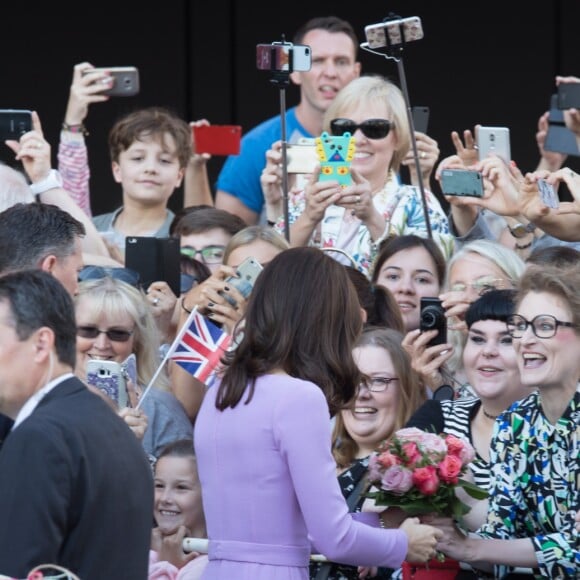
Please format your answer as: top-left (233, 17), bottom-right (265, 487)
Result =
top-left (112, 134), bottom-right (185, 207)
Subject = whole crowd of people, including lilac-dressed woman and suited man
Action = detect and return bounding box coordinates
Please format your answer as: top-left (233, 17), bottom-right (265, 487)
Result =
top-left (0, 16), bottom-right (580, 580)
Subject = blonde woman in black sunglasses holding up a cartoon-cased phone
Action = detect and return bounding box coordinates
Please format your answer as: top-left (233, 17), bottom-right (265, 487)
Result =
top-left (262, 75), bottom-right (453, 274)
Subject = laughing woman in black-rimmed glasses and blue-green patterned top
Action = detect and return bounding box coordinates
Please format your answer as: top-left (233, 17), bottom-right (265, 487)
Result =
top-left (434, 265), bottom-right (580, 579)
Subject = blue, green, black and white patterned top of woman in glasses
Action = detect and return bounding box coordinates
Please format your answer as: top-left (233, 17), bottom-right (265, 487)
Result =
top-left (478, 387), bottom-right (580, 579)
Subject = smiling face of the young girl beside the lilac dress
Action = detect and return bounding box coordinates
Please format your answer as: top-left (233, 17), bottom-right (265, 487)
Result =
top-left (153, 457), bottom-right (205, 535)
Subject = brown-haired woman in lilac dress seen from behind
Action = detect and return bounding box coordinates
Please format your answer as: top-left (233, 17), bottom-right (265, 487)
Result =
top-left (194, 247), bottom-right (439, 580)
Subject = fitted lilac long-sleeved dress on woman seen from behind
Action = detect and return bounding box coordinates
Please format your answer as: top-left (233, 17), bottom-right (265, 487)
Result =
top-left (194, 375), bottom-right (407, 580)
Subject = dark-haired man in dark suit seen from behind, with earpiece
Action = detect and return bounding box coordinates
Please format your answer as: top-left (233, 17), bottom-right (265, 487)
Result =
top-left (0, 269), bottom-right (153, 580)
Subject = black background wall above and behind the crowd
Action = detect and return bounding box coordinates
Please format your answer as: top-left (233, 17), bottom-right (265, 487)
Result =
top-left (0, 0), bottom-right (580, 214)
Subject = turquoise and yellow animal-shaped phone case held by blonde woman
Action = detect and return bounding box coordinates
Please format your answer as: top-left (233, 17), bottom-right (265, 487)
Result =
top-left (315, 131), bottom-right (355, 187)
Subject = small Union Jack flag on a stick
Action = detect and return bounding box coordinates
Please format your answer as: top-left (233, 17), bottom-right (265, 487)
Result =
top-left (169, 310), bottom-right (232, 383)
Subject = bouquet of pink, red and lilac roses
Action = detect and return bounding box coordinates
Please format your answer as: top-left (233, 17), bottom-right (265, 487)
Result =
top-left (366, 427), bottom-right (488, 517)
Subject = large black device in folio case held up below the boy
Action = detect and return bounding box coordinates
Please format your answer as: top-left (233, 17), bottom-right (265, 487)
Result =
top-left (125, 236), bottom-right (181, 296)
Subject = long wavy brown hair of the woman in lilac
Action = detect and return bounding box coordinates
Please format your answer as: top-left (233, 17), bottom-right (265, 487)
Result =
top-left (216, 247), bottom-right (362, 415)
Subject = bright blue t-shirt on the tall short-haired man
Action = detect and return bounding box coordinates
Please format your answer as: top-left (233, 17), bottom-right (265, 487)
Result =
top-left (216, 107), bottom-right (313, 214)
